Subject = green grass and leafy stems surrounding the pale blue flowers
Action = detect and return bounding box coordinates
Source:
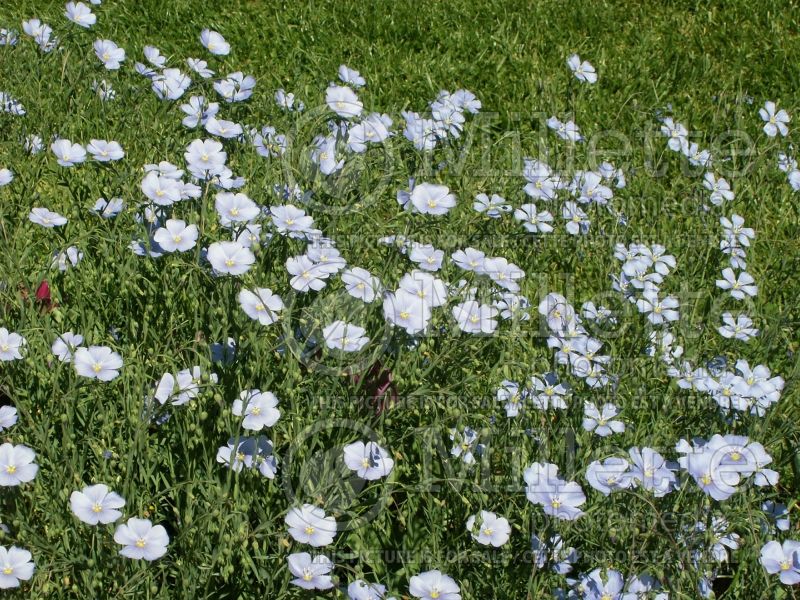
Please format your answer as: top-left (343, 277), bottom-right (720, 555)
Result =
top-left (0, 0), bottom-right (800, 600)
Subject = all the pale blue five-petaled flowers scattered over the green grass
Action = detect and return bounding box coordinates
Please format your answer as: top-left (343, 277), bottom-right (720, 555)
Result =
top-left (0, 2), bottom-right (800, 600)
